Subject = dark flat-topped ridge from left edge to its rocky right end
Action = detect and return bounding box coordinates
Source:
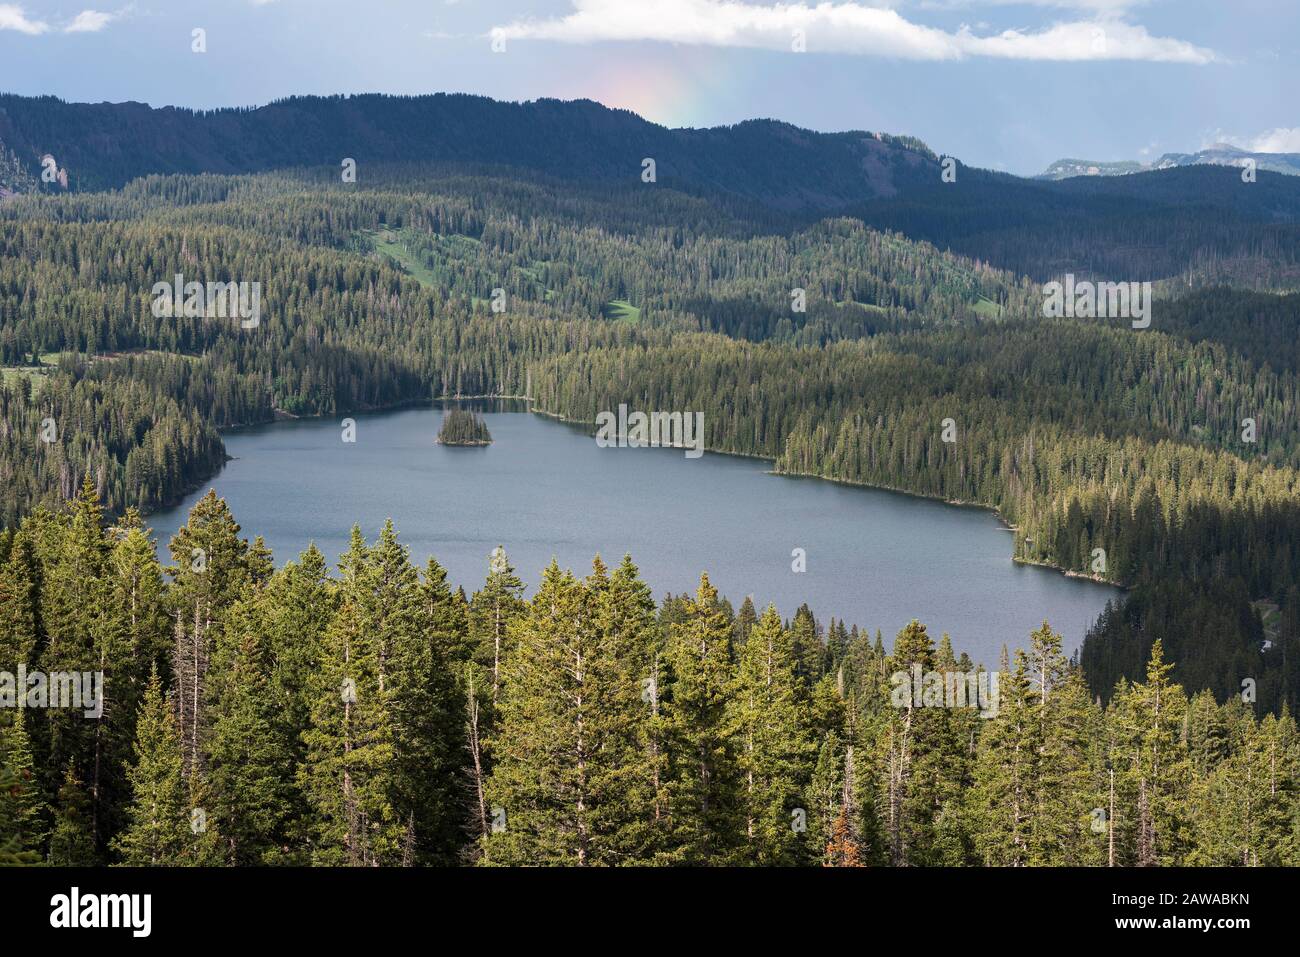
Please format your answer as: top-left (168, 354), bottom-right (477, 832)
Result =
top-left (0, 94), bottom-right (939, 209)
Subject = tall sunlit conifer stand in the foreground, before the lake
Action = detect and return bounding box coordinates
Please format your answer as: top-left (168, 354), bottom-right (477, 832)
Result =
top-left (0, 482), bottom-right (1300, 866)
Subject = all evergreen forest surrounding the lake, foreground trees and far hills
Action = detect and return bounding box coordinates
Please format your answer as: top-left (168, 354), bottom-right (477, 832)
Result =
top-left (0, 98), bottom-right (1300, 866)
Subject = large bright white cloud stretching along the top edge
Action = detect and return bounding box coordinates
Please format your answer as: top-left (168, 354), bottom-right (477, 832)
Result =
top-left (493, 0), bottom-right (1216, 64)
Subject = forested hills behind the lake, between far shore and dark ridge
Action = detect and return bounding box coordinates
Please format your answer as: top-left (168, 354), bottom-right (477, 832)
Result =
top-left (0, 168), bottom-right (1300, 709)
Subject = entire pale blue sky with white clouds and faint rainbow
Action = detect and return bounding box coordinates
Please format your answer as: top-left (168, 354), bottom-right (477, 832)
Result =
top-left (0, 0), bottom-right (1300, 174)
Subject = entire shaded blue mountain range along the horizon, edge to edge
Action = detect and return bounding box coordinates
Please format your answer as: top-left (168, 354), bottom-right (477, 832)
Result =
top-left (0, 94), bottom-right (1300, 286)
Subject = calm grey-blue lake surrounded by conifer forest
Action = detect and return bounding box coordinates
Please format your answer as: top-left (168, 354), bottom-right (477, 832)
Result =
top-left (148, 408), bottom-right (1119, 667)
